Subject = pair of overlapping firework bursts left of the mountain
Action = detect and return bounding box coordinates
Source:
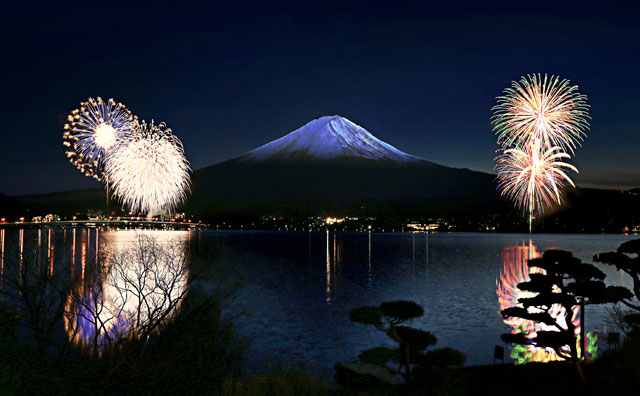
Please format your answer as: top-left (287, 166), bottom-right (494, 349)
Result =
top-left (63, 97), bottom-right (191, 215)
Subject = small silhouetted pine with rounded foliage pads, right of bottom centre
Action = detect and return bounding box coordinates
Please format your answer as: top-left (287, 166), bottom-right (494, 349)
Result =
top-left (349, 301), bottom-right (466, 383)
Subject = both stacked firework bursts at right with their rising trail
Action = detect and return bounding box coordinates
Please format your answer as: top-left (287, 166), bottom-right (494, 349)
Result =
top-left (491, 74), bottom-right (590, 231)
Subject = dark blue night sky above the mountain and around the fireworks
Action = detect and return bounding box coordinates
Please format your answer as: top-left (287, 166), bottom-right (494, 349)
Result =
top-left (0, 0), bottom-right (640, 195)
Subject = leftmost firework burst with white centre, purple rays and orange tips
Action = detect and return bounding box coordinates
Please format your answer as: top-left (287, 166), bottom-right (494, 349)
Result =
top-left (62, 97), bottom-right (137, 180)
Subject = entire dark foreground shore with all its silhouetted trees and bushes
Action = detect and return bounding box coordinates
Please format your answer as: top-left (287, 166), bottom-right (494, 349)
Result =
top-left (0, 239), bottom-right (640, 396)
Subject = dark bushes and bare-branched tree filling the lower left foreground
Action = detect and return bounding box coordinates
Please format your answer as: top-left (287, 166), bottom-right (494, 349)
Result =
top-left (0, 232), bottom-right (244, 395)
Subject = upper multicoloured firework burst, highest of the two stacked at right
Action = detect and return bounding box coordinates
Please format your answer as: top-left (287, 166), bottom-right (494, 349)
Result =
top-left (491, 74), bottom-right (590, 153)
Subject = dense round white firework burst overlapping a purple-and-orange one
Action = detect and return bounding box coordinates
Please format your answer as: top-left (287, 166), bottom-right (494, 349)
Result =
top-left (105, 121), bottom-right (191, 215)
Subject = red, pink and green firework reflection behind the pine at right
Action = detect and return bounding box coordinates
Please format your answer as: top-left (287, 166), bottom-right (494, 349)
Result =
top-left (496, 241), bottom-right (580, 363)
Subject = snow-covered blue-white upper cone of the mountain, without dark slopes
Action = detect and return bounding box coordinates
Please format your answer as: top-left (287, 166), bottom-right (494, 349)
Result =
top-left (239, 115), bottom-right (425, 162)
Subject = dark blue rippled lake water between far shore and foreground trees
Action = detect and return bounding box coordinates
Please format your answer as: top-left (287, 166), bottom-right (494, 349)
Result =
top-left (0, 229), bottom-right (634, 378)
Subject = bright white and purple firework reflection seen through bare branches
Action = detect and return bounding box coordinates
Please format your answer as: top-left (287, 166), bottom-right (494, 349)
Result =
top-left (65, 231), bottom-right (188, 351)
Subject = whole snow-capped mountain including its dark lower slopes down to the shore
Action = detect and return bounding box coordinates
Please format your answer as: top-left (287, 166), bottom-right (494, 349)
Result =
top-left (185, 116), bottom-right (504, 216)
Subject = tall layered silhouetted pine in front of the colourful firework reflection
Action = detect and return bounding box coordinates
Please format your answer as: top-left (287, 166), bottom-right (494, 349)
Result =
top-left (501, 250), bottom-right (631, 362)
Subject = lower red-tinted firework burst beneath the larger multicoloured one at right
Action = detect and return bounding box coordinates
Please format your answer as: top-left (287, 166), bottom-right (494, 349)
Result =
top-left (496, 141), bottom-right (578, 218)
